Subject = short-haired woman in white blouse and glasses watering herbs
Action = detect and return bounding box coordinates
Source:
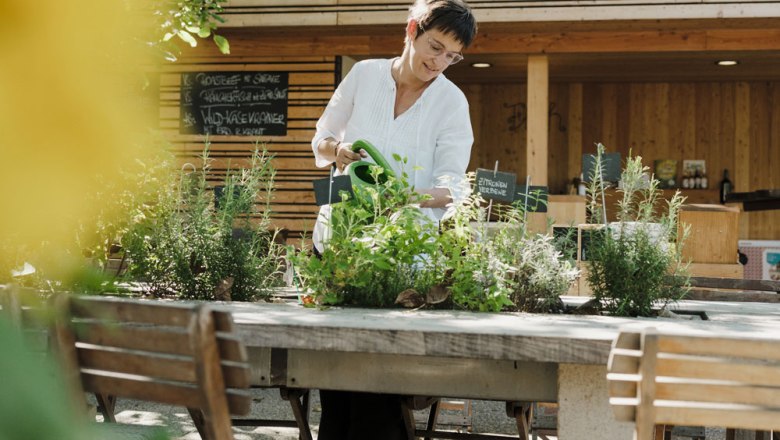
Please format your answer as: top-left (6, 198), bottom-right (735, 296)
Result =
top-left (312, 0), bottom-right (477, 440)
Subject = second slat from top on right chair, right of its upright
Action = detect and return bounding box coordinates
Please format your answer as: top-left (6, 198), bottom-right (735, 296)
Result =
top-left (656, 358), bottom-right (780, 386)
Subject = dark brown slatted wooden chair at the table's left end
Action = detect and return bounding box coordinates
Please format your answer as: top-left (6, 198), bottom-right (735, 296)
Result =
top-left (54, 295), bottom-right (251, 440)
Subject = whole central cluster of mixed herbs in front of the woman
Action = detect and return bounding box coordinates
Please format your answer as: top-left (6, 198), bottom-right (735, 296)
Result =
top-left (295, 165), bottom-right (578, 312)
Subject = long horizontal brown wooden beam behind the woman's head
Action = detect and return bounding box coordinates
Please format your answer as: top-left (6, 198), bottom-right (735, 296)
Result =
top-left (186, 23), bottom-right (780, 57)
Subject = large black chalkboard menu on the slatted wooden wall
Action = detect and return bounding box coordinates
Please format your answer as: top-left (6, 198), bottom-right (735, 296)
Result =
top-left (179, 72), bottom-right (288, 136)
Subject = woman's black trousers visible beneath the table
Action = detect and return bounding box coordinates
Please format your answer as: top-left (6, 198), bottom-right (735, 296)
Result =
top-left (317, 390), bottom-right (407, 440)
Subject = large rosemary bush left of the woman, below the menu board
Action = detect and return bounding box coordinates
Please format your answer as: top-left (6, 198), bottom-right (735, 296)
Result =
top-left (122, 142), bottom-right (281, 301)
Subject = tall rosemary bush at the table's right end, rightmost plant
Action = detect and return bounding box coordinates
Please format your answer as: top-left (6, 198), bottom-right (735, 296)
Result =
top-left (588, 144), bottom-right (688, 316)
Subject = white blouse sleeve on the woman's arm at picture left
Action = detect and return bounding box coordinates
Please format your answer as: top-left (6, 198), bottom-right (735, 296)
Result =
top-left (311, 63), bottom-right (360, 168)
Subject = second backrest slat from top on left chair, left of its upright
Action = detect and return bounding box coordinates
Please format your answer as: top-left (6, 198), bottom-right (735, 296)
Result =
top-left (75, 321), bottom-right (192, 355)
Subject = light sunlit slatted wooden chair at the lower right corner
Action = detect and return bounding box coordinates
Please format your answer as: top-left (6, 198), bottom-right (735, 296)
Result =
top-left (607, 329), bottom-right (780, 440)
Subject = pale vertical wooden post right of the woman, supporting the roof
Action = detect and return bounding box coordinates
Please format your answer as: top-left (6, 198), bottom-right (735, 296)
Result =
top-left (526, 55), bottom-right (549, 185)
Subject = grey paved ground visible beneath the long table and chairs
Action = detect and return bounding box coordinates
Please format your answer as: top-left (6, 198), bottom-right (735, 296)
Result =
top-left (98, 389), bottom-right (517, 440)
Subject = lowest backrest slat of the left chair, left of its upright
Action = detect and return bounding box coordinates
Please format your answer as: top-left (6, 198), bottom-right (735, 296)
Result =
top-left (81, 371), bottom-right (201, 406)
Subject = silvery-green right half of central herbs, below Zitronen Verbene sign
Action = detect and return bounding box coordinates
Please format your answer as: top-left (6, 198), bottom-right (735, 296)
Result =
top-left (441, 179), bottom-right (578, 312)
